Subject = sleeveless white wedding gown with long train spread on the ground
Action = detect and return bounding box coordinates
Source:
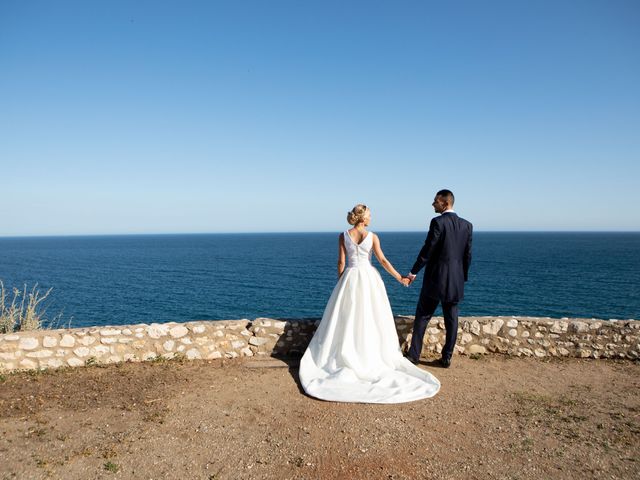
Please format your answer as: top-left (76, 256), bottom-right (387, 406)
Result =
top-left (300, 232), bottom-right (440, 403)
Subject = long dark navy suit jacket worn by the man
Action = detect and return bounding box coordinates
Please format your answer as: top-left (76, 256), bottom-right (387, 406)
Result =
top-left (411, 212), bottom-right (473, 303)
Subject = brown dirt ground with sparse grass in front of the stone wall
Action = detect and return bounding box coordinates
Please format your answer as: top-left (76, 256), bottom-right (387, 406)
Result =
top-left (0, 356), bottom-right (640, 480)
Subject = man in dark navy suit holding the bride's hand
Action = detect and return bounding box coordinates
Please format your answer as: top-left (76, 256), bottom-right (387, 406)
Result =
top-left (403, 190), bottom-right (473, 368)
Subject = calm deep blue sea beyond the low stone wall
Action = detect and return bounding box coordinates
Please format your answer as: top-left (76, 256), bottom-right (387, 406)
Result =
top-left (0, 232), bottom-right (640, 327)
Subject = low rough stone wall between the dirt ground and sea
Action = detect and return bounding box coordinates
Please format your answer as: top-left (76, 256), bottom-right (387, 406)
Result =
top-left (0, 316), bottom-right (640, 372)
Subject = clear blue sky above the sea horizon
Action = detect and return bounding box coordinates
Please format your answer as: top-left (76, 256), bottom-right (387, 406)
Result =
top-left (0, 0), bottom-right (640, 235)
